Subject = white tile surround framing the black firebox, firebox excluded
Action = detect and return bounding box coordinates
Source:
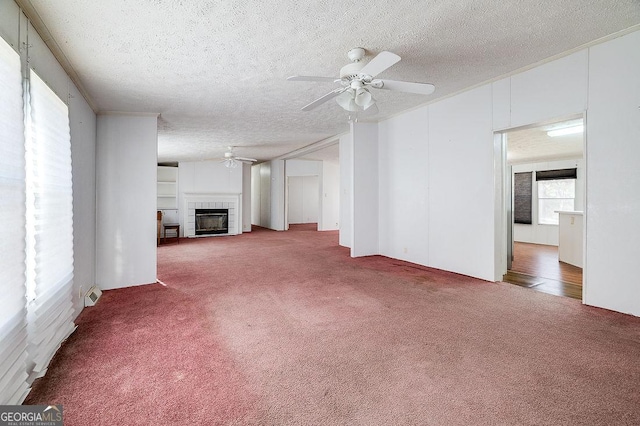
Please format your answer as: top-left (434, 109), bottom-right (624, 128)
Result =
top-left (182, 192), bottom-right (242, 238)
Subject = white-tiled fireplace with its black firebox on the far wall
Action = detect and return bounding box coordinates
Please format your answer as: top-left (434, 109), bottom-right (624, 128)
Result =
top-left (182, 193), bottom-right (242, 237)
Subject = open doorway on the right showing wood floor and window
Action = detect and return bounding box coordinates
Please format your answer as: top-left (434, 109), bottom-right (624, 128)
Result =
top-left (501, 116), bottom-right (586, 300)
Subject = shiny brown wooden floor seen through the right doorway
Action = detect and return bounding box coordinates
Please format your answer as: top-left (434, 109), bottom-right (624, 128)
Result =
top-left (503, 242), bottom-right (582, 299)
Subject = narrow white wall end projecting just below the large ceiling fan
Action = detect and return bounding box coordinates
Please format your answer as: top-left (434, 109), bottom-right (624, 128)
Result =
top-left (351, 122), bottom-right (380, 257)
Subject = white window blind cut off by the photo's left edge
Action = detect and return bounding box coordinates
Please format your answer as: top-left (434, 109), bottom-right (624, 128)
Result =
top-left (0, 38), bottom-right (28, 404)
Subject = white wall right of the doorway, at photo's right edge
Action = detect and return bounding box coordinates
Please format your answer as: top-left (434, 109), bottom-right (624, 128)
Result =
top-left (584, 32), bottom-right (640, 316)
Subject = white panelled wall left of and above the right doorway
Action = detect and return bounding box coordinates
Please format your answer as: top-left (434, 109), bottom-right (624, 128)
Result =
top-left (379, 42), bottom-right (588, 280)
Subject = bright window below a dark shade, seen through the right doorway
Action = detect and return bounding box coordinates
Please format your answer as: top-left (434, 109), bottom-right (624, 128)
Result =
top-left (538, 179), bottom-right (576, 225)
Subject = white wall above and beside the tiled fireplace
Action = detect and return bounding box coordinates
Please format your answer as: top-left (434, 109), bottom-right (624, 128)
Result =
top-left (178, 161), bottom-right (242, 236)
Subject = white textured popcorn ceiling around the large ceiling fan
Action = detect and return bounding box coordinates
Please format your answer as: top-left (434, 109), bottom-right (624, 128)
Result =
top-left (17, 0), bottom-right (640, 161)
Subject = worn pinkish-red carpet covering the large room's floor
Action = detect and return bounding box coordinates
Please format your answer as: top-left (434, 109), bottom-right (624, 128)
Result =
top-left (26, 226), bottom-right (640, 425)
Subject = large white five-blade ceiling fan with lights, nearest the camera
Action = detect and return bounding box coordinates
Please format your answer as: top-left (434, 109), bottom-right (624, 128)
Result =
top-left (287, 47), bottom-right (435, 112)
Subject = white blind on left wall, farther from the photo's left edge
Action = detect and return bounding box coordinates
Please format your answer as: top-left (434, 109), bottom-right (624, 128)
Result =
top-left (26, 70), bottom-right (74, 381)
